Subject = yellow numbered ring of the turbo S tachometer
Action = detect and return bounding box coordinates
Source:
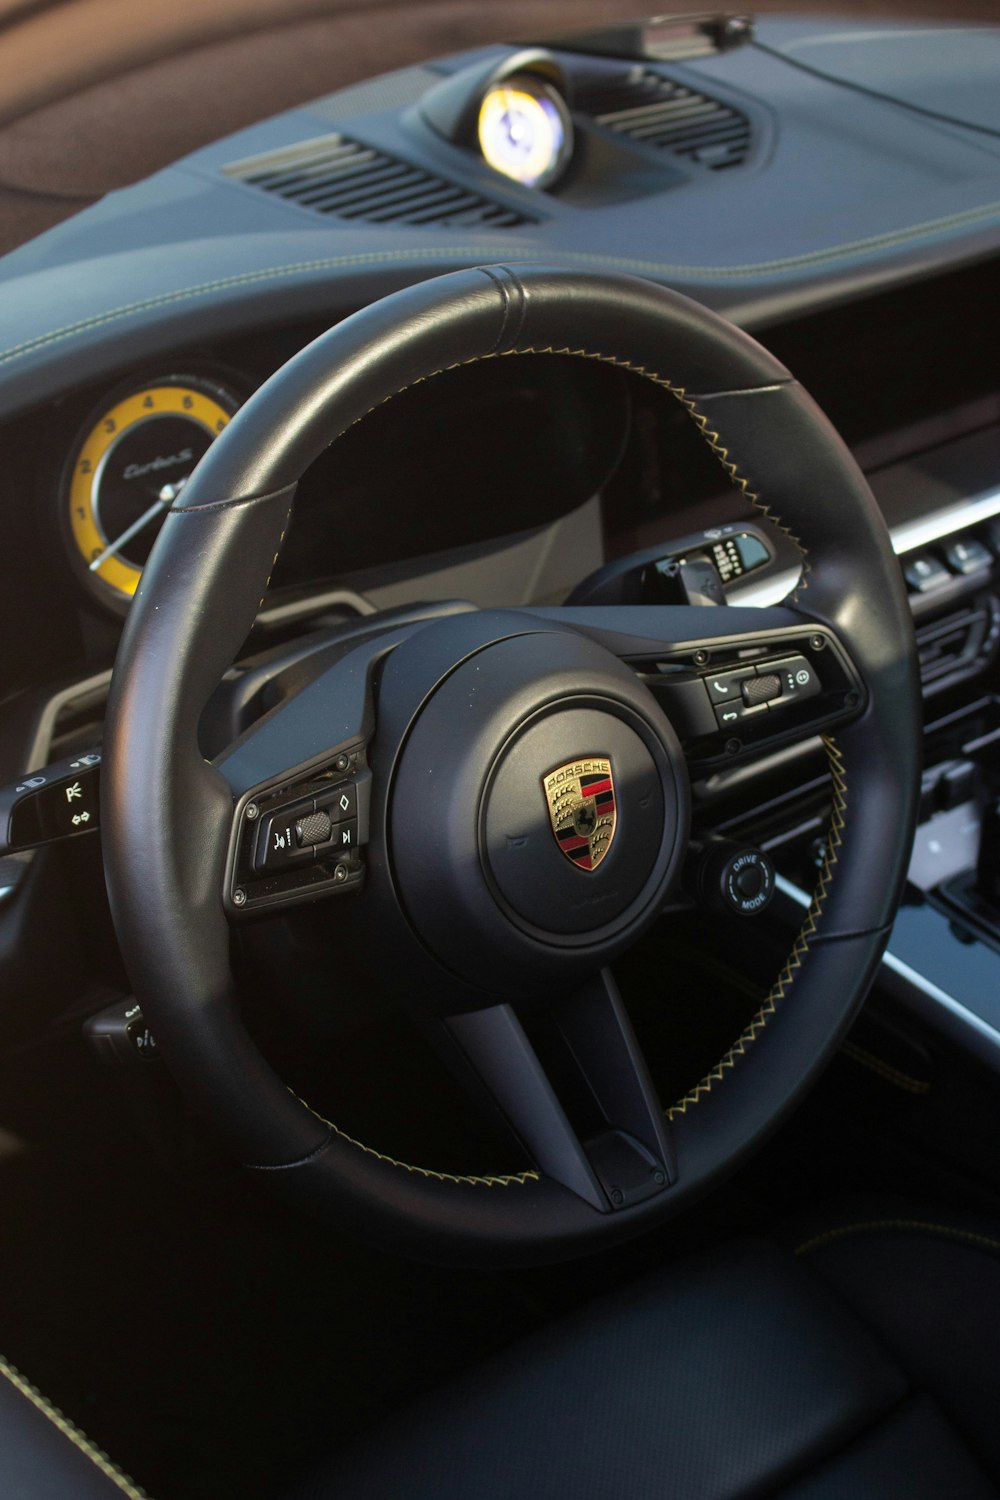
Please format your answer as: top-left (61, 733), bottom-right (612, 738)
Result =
top-left (58, 371), bottom-right (246, 615)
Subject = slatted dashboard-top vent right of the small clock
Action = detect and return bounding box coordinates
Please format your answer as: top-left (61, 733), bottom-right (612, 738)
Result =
top-left (585, 68), bottom-right (751, 173)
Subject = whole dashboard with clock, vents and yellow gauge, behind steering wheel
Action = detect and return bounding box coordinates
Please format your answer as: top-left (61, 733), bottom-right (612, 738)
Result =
top-left (0, 11), bottom-right (1000, 1092)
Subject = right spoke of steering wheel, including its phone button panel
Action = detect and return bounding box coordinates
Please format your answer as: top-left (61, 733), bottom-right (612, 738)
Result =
top-left (530, 605), bottom-right (867, 774)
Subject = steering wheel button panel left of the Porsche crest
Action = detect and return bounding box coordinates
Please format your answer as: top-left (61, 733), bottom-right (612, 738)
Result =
top-left (225, 749), bottom-right (372, 917)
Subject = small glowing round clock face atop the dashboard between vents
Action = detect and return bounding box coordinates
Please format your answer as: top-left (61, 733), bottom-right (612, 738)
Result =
top-left (478, 74), bottom-right (573, 188)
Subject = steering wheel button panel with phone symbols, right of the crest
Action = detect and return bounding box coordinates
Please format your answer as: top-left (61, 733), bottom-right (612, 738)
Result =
top-left (643, 626), bottom-right (864, 767)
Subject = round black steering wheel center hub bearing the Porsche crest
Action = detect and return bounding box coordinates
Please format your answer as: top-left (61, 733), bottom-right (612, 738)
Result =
top-left (388, 630), bottom-right (688, 995)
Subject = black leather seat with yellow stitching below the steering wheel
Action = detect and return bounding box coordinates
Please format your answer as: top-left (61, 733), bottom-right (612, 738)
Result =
top-left (0, 1215), bottom-right (1000, 1500)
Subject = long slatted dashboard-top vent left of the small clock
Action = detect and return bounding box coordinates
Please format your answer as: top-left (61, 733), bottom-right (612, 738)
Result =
top-left (223, 135), bottom-right (535, 230)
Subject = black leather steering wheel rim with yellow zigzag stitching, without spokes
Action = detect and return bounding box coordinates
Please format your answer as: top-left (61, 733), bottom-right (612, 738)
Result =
top-left (102, 266), bottom-right (921, 1263)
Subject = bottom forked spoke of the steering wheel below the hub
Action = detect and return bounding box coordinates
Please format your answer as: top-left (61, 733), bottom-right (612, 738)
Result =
top-left (444, 971), bottom-right (675, 1214)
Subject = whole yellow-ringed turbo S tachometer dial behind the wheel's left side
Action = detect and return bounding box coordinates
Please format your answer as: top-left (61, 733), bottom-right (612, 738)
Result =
top-left (60, 375), bottom-right (241, 611)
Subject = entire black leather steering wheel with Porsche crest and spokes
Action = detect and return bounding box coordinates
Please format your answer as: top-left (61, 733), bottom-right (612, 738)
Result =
top-left (102, 266), bottom-right (921, 1263)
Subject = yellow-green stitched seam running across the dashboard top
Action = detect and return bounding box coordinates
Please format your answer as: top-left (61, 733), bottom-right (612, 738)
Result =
top-left (0, 189), bottom-right (1000, 366)
